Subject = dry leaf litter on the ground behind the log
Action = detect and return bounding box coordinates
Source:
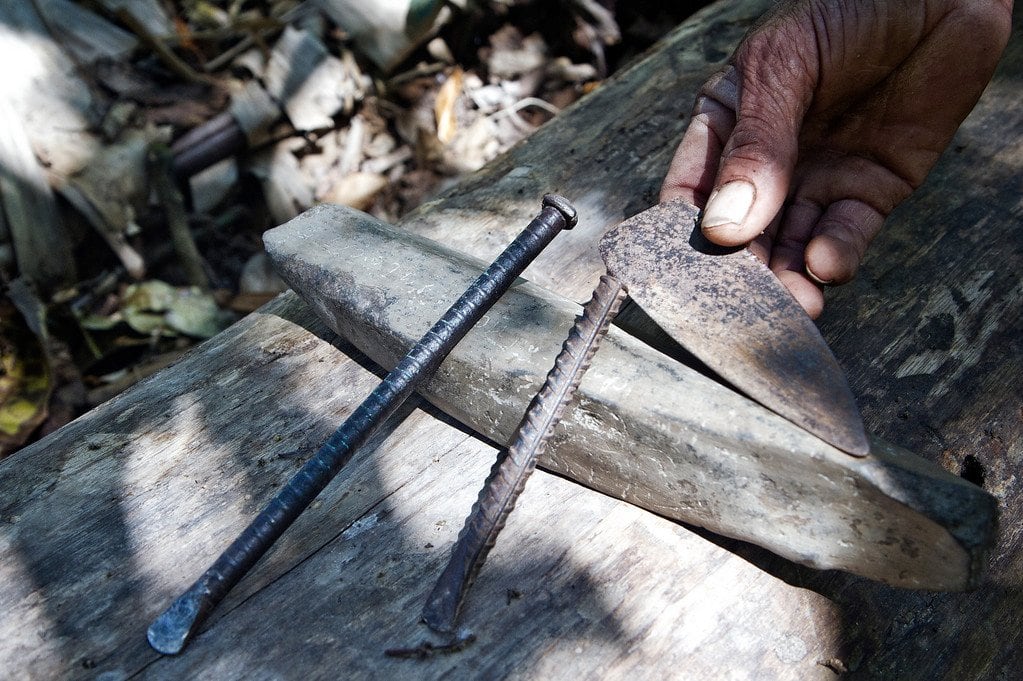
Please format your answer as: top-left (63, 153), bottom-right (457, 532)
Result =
top-left (0, 0), bottom-right (707, 457)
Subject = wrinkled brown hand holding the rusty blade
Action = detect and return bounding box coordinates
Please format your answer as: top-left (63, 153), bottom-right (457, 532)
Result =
top-left (661, 0), bottom-right (1013, 317)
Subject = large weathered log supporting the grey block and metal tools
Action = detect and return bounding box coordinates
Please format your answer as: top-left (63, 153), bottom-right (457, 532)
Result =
top-left (0, 1), bottom-right (1023, 681)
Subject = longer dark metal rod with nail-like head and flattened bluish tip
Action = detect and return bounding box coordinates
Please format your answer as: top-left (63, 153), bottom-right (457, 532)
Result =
top-left (147, 194), bottom-right (577, 654)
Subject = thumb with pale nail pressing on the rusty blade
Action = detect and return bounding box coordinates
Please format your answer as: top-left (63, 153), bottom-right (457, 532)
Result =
top-left (702, 51), bottom-right (813, 245)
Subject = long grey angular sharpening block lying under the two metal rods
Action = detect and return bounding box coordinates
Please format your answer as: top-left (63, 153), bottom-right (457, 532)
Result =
top-left (264, 206), bottom-right (996, 590)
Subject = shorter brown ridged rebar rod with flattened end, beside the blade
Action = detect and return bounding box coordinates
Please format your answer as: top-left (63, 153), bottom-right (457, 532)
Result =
top-left (422, 276), bottom-right (625, 634)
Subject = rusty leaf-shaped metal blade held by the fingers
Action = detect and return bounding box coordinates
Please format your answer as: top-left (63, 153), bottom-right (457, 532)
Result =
top-left (601, 200), bottom-right (870, 456)
